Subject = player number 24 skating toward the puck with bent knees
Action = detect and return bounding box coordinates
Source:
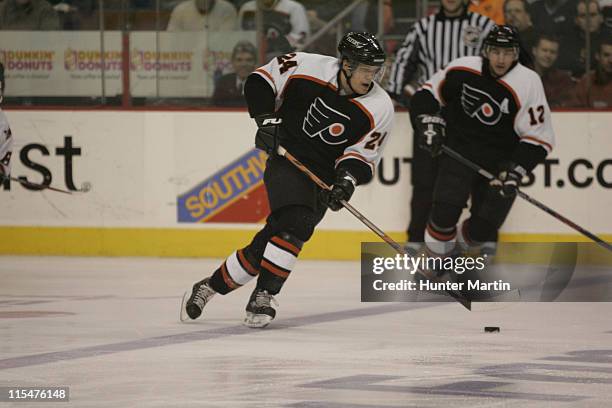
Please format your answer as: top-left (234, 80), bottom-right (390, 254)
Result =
top-left (181, 32), bottom-right (394, 327)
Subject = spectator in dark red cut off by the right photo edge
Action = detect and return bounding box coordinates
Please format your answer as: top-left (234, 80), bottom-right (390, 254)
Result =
top-left (576, 36), bottom-right (612, 109)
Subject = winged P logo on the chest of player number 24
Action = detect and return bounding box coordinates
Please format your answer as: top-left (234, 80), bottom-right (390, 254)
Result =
top-left (302, 98), bottom-right (351, 145)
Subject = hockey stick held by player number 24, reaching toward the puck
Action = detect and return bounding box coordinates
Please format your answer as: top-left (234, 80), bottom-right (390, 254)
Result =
top-left (277, 146), bottom-right (472, 310)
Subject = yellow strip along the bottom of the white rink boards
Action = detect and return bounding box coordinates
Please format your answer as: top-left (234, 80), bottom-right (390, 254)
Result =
top-left (0, 227), bottom-right (612, 264)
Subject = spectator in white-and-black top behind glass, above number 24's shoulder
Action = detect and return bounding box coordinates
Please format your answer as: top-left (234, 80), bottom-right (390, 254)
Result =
top-left (238, 0), bottom-right (310, 60)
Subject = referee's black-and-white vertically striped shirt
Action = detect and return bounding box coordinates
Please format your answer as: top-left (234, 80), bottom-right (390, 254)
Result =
top-left (387, 10), bottom-right (495, 100)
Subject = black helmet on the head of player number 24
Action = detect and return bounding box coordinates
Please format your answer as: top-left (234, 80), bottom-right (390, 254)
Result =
top-left (338, 31), bottom-right (387, 66)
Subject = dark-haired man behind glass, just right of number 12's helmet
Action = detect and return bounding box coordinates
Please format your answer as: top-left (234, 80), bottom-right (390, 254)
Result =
top-left (533, 34), bottom-right (576, 108)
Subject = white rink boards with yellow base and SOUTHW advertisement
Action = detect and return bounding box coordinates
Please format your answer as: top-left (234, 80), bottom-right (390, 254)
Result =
top-left (0, 110), bottom-right (612, 259)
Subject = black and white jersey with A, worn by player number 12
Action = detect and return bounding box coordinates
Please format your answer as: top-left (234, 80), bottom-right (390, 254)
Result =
top-left (413, 57), bottom-right (555, 171)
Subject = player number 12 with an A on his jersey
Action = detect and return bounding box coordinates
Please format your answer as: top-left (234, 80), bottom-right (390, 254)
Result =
top-left (410, 26), bottom-right (554, 254)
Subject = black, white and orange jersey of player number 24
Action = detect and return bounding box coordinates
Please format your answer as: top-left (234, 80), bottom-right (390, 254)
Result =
top-left (254, 52), bottom-right (394, 184)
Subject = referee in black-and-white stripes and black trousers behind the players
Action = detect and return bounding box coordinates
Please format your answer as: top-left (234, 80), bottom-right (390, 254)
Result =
top-left (387, 0), bottom-right (495, 246)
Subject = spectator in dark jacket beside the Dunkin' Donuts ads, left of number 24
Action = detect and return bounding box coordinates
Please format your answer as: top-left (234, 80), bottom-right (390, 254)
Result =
top-left (213, 41), bottom-right (257, 106)
